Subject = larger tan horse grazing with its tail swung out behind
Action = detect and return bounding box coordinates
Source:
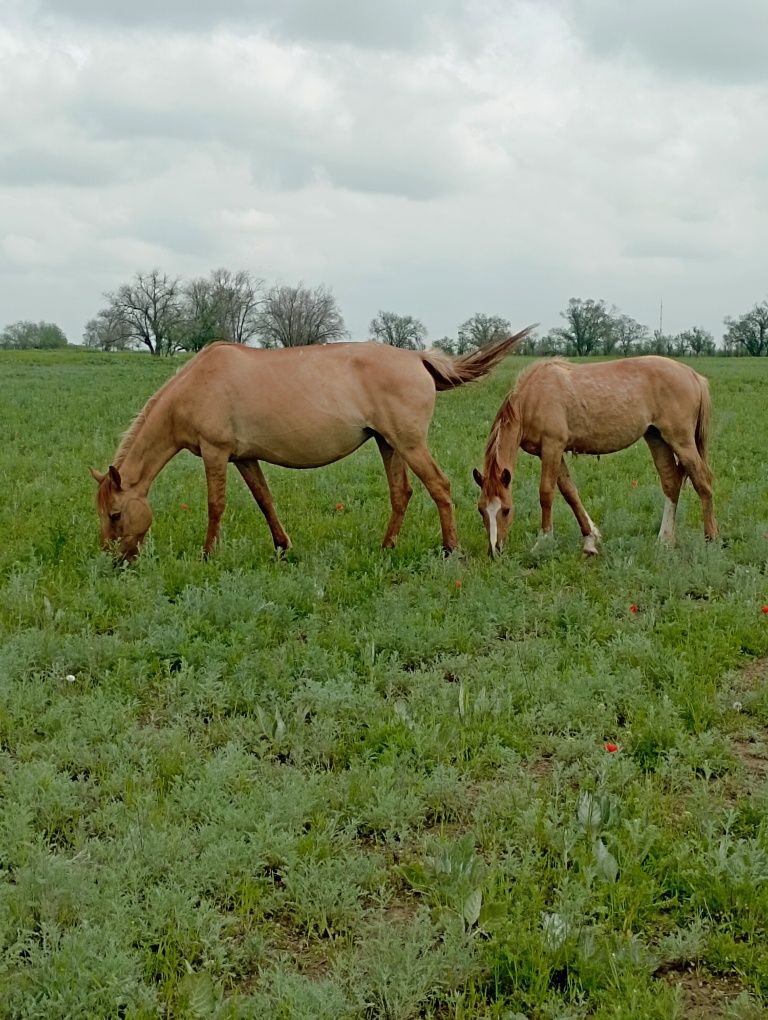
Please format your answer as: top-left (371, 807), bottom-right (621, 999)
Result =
top-left (91, 329), bottom-right (529, 559)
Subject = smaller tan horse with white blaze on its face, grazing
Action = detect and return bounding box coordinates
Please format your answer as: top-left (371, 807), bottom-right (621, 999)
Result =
top-left (473, 355), bottom-right (717, 556)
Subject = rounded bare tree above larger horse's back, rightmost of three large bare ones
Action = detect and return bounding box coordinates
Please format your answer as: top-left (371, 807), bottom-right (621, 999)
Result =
top-left (256, 284), bottom-right (349, 347)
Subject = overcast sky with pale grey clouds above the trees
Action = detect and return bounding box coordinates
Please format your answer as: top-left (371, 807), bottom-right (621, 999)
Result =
top-left (0, 0), bottom-right (768, 341)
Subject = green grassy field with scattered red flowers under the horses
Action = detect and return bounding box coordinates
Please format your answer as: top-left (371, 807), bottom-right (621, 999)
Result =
top-left (0, 353), bottom-right (768, 1020)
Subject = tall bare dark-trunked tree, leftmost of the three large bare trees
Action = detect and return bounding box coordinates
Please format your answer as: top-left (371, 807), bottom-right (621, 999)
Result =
top-left (100, 269), bottom-right (184, 355)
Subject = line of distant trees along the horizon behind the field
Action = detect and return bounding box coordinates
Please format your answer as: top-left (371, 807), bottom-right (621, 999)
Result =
top-left (0, 268), bottom-right (768, 357)
